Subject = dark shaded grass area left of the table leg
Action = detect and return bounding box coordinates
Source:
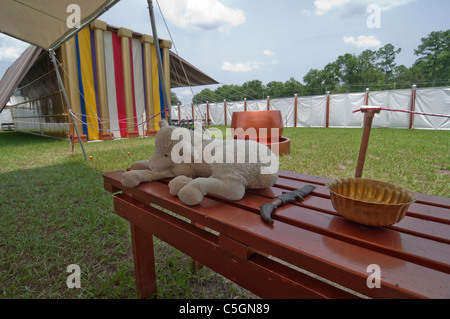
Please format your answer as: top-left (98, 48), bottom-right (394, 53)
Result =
top-left (0, 161), bottom-right (136, 299)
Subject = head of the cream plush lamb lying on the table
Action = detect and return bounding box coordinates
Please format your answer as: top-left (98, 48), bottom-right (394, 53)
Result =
top-left (149, 120), bottom-right (201, 171)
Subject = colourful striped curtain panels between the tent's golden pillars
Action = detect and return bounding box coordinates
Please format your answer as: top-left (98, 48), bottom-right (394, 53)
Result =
top-left (75, 27), bottom-right (165, 140)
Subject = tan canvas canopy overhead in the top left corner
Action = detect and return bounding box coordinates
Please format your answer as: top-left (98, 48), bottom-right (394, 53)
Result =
top-left (0, 0), bottom-right (118, 50)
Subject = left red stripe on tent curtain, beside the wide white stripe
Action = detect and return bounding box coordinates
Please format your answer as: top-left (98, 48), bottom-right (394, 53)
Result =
top-left (112, 32), bottom-right (127, 137)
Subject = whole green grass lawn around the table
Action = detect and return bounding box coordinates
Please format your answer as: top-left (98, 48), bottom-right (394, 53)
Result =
top-left (0, 127), bottom-right (450, 298)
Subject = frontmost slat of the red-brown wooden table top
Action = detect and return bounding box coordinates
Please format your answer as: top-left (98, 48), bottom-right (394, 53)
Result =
top-left (105, 172), bottom-right (448, 298)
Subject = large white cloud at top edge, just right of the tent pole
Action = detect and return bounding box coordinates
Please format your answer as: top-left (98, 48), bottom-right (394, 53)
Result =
top-left (159, 0), bottom-right (245, 31)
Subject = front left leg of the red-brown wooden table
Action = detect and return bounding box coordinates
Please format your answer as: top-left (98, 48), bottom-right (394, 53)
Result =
top-left (131, 224), bottom-right (156, 298)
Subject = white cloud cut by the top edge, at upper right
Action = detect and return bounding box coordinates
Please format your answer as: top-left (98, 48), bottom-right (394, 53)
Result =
top-left (314, 0), bottom-right (415, 16)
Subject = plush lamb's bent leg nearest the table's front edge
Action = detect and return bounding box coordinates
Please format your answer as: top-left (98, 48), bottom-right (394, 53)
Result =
top-left (178, 177), bottom-right (245, 205)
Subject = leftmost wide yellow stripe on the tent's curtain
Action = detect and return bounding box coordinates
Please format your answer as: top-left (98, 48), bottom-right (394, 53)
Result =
top-left (78, 27), bottom-right (99, 140)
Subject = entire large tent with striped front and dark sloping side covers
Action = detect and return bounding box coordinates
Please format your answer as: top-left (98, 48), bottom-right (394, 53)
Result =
top-left (0, 20), bottom-right (217, 140)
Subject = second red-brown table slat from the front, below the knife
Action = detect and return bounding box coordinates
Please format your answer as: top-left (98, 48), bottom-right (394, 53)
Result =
top-left (223, 193), bottom-right (450, 273)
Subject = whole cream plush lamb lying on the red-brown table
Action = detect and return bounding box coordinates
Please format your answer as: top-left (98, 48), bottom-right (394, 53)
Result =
top-left (121, 120), bottom-right (278, 205)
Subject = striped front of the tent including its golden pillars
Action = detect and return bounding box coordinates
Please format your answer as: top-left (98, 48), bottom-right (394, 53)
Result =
top-left (62, 20), bottom-right (176, 140)
